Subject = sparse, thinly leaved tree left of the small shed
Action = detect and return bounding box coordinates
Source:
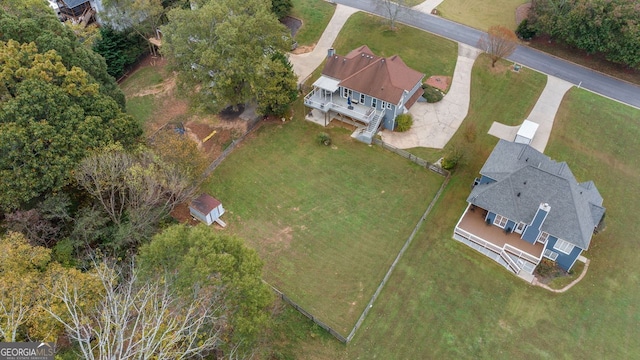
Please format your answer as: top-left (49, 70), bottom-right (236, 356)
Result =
top-left (75, 146), bottom-right (200, 252)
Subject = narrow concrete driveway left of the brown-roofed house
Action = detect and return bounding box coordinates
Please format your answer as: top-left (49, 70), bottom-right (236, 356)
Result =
top-left (289, 4), bottom-right (359, 82)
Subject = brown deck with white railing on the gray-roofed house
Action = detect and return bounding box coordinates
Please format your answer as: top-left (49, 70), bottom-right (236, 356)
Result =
top-left (453, 206), bottom-right (544, 275)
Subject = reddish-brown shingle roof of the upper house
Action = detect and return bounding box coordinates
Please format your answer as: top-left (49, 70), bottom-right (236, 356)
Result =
top-left (322, 45), bottom-right (424, 104)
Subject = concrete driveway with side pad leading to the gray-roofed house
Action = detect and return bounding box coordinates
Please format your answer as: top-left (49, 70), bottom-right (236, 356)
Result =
top-left (489, 76), bottom-right (573, 153)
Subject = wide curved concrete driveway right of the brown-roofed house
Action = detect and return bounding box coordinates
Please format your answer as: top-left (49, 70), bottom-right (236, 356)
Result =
top-left (380, 43), bottom-right (480, 149)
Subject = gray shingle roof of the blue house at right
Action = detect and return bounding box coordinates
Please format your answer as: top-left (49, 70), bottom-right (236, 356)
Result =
top-left (467, 140), bottom-right (605, 250)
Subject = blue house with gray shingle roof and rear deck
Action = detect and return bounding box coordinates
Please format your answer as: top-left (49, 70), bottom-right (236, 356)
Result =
top-left (453, 140), bottom-right (605, 275)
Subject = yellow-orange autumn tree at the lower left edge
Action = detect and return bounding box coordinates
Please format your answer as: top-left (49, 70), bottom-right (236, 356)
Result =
top-left (0, 233), bottom-right (99, 342)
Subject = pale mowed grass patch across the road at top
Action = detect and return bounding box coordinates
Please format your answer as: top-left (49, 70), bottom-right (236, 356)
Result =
top-left (437, 0), bottom-right (528, 31)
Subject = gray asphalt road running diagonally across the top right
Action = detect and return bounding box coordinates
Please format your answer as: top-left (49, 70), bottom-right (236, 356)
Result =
top-left (333, 0), bottom-right (640, 109)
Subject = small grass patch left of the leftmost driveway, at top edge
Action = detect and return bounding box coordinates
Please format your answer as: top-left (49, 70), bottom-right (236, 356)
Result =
top-left (291, 0), bottom-right (336, 45)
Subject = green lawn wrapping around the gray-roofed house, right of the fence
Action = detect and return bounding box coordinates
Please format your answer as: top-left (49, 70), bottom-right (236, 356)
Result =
top-left (286, 55), bottom-right (640, 359)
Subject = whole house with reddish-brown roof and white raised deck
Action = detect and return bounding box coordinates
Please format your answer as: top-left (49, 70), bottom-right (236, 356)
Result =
top-left (304, 45), bottom-right (424, 143)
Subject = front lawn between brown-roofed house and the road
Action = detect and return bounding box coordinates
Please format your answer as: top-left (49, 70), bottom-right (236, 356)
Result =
top-left (333, 12), bottom-right (458, 77)
